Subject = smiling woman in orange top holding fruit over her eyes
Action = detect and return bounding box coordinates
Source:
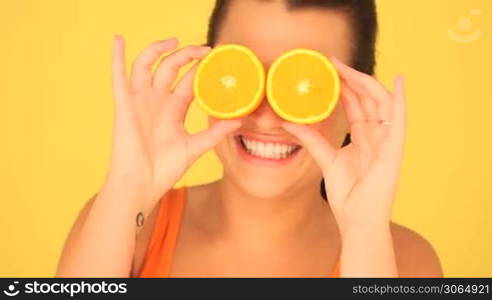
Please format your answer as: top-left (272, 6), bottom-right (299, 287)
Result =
top-left (57, 0), bottom-right (442, 277)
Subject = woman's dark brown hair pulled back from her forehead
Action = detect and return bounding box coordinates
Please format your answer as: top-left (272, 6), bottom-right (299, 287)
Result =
top-left (207, 0), bottom-right (378, 200)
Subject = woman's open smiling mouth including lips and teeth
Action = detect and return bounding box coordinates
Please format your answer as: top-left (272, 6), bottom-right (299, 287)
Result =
top-left (235, 135), bottom-right (302, 160)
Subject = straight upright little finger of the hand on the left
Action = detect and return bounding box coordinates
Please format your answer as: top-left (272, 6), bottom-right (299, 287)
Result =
top-left (112, 35), bottom-right (128, 101)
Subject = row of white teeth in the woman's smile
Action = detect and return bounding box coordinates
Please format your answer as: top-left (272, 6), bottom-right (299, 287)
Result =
top-left (240, 136), bottom-right (299, 159)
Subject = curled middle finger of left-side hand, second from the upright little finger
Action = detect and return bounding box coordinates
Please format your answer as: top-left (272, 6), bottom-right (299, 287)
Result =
top-left (153, 46), bottom-right (211, 91)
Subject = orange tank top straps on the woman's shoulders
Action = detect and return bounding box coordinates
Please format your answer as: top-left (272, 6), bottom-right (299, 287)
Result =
top-left (138, 187), bottom-right (340, 278)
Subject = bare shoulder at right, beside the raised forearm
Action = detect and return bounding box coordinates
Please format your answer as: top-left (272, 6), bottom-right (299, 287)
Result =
top-left (391, 222), bottom-right (443, 277)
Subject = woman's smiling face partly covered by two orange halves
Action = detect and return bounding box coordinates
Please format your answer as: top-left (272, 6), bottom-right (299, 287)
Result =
top-left (209, 0), bottom-right (351, 198)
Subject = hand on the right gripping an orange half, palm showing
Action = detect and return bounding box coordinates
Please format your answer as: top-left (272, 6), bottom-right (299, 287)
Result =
top-left (283, 59), bottom-right (406, 239)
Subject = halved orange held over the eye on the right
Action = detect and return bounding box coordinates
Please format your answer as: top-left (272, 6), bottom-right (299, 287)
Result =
top-left (266, 49), bottom-right (340, 124)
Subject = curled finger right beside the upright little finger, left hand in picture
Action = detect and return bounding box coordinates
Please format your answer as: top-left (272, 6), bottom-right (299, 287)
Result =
top-left (131, 38), bottom-right (178, 90)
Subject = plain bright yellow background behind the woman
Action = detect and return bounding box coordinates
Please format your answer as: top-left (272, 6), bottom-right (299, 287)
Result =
top-left (0, 0), bottom-right (492, 277)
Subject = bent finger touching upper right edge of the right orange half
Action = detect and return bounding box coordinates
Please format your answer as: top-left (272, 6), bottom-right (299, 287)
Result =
top-left (332, 57), bottom-right (392, 120)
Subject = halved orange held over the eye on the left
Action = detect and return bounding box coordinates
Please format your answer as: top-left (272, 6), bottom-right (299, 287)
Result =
top-left (193, 44), bottom-right (266, 119)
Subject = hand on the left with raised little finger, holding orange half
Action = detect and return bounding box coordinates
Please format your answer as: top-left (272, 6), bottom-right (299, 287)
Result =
top-left (103, 36), bottom-right (241, 212)
